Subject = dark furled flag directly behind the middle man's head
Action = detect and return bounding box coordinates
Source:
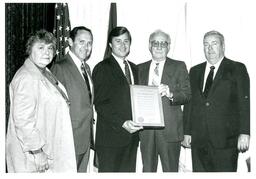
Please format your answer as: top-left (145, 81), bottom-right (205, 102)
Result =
top-left (104, 2), bottom-right (117, 59)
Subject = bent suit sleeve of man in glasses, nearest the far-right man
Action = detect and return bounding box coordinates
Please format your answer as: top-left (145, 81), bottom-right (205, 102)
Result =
top-left (172, 62), bottom-right (191, 105)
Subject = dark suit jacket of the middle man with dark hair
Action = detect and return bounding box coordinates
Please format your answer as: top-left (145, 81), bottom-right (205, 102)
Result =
top-left (92, 56), bottom-right (138, 147)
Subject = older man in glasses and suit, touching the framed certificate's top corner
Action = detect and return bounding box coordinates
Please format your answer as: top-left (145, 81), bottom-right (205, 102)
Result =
top-left (139, 30), bottom-right (191, 172)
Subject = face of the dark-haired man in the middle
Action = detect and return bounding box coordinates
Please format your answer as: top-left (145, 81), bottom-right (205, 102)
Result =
top-left (109, 33), bottom-right (131, 58)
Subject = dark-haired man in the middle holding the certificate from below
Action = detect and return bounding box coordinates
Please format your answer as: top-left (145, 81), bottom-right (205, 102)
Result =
top-left (92, 27), bottom-right (141, 172)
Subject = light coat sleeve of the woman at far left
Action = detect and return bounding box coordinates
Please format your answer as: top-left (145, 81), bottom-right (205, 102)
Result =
top-left (10, 76), bottom-right (45, 152)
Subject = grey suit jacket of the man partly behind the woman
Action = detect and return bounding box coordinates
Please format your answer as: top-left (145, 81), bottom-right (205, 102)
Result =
top-left (51, 54), bottom-right (93, 154)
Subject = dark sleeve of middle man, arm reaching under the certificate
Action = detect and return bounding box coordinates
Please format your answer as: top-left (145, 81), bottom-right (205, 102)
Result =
top-left (92, 65), bottom-right (124, 132)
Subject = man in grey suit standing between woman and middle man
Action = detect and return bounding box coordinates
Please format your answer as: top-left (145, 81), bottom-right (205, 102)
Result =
top-left (51, 26), bottom-right (93, 172)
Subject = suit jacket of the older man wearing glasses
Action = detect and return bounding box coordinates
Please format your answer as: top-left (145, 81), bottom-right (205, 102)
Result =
top-left (139, 58), bottom-right (191, 142)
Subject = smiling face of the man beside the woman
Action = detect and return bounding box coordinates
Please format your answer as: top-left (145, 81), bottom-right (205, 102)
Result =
top-left (69, 30), bottom-right (92, 61)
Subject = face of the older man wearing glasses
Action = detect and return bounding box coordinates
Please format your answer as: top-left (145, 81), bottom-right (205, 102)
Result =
top-left (149, 34), bottom-right (170, 61)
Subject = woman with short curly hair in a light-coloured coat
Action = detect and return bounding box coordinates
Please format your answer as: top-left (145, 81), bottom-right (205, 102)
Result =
top-left (6, 30), bottom-right (76, 172)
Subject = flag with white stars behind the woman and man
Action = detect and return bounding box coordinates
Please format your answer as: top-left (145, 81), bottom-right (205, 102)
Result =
top-left (53, 3), bottom-right (71, 61)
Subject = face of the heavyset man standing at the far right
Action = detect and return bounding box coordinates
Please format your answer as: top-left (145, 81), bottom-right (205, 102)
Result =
top-left (204, 35), bottom-right (224, 65)
